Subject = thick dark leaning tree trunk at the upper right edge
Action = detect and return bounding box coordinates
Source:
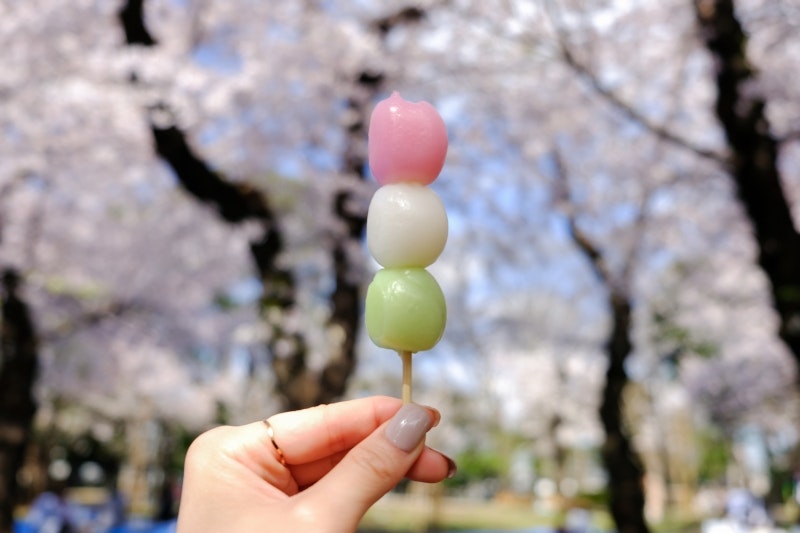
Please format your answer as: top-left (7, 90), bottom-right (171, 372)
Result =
top-left (694, 0), bottom-right (800, 368)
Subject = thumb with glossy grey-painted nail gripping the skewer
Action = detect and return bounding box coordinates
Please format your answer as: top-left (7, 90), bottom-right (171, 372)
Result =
top-left (303, 403), bottom-right (435, 529)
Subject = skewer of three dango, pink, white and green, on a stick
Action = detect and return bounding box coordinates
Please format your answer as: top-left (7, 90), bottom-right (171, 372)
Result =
top-left (364, 92), bottom-right (448, 402)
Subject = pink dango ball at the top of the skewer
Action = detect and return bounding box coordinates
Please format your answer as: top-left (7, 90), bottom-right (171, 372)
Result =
top-left (369, 92), bottom-right (447, 185)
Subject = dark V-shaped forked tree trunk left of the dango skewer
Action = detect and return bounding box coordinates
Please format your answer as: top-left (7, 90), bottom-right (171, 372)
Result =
top-left (119, 0), bottom-right (425, 409)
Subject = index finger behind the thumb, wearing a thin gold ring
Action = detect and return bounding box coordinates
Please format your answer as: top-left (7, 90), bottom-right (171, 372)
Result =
top-left (269, 396), bottom-right (439, 464)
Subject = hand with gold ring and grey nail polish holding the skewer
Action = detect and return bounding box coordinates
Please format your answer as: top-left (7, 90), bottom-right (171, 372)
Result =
top-left (177, 397), bottom-right (455, 533)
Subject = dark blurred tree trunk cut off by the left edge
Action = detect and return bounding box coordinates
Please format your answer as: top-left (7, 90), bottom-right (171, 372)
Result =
top-left (0, 270), bottom-right (39, 533)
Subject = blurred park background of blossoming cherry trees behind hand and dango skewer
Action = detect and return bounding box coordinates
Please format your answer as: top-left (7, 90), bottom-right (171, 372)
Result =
top-left (0, 0), bottom-right (800, 532)
